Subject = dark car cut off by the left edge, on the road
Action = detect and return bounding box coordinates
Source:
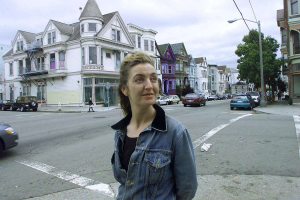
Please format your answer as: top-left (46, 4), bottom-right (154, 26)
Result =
top-left (0, 122), bottom-right (19, 153)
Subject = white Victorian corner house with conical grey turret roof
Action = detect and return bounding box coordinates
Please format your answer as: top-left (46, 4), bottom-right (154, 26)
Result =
top-left (3, 0), bottom-right (134, 105)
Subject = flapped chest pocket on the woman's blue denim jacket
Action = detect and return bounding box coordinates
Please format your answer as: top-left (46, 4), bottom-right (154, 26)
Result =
top-left (145, 152), bottom-right (171, 185)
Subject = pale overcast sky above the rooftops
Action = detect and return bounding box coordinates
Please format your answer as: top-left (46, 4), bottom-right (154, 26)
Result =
top-left (0, 0), bottom-right (283, 68)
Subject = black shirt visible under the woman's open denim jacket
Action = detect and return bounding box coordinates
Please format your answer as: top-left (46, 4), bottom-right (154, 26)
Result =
top-left (120, 134), bottom-right (137, 172)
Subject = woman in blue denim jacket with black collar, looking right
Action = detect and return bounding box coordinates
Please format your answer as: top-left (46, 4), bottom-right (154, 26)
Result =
top-left (111, 52), bottom-right (198, 200)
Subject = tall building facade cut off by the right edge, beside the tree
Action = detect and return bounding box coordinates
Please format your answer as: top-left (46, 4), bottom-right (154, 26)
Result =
top-left (277, 0), bottom-right (300, 102)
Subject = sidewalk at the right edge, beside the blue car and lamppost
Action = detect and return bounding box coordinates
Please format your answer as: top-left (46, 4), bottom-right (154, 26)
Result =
top-left (253, 100), bottom-right (300, 116)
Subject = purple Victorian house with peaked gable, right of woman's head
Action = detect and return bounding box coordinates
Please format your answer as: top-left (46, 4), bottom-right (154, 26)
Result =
top-left (158, 44), bottom-right (176, 95)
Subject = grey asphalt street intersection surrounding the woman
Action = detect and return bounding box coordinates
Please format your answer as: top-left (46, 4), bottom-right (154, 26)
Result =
top-left (0, 100), bottom-right (300, 200)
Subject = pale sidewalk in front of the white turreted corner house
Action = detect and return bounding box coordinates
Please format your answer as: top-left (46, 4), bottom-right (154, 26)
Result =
top-left (38, 104), bottom-right (120, 113)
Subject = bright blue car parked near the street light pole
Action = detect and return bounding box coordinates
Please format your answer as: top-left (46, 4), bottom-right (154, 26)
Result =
top-left (230, 94), bottom-right (255, 110)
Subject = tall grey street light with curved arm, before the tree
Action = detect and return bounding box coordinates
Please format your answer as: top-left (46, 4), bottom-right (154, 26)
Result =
top-left (228, 18), bottom-right (266, 107)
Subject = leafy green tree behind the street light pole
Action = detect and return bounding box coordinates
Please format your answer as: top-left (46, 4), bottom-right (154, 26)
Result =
top-left (235, 30), bottom-right (282, 101)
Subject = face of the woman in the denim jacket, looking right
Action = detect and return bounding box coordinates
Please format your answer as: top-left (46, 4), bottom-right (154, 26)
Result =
top-left (122, 63), bottom-right (158, 107)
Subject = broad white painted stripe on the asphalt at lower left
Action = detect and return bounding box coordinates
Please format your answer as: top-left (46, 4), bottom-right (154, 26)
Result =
top-left (17, 160), bottom-right (116, 197)
